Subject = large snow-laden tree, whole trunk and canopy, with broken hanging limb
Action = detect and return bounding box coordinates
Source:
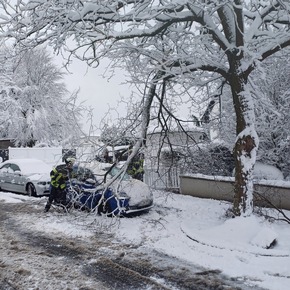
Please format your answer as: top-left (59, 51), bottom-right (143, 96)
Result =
top-left (1, 0), bottom-right (290, 215)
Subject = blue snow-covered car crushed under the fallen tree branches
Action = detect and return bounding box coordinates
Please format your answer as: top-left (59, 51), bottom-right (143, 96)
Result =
top-left (68, 166), bottom-right (153, 216)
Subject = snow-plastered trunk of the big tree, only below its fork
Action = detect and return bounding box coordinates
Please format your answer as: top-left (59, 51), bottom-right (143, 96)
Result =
top-left (230, 66), bottom-right (258, 216)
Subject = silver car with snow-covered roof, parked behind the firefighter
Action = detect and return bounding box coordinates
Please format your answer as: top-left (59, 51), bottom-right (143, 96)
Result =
top-left (0, 159), bottom-right (51, 196)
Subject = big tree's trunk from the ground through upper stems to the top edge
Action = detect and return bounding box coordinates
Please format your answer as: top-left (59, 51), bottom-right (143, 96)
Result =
top-left (218, 0), bottom-right (258, 216)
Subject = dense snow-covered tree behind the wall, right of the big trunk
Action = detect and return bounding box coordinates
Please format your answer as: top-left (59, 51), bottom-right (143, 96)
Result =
top-left (256, 49), bottom-right (290, 179)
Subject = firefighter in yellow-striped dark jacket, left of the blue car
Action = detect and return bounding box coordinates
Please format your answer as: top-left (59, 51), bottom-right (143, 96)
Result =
top-left (44, 158), bottom-right (75, 212)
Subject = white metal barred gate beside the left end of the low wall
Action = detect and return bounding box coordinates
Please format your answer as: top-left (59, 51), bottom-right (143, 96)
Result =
top-left (144, 167), bottom-right (180, 191)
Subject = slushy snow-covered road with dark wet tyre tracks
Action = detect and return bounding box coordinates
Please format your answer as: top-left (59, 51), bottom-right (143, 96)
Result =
top-left (0, 193), bottom-right (278, 290)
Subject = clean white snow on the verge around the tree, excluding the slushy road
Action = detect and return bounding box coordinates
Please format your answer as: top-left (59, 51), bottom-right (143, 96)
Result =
top-left (0, 191), bottom-right (290, 290)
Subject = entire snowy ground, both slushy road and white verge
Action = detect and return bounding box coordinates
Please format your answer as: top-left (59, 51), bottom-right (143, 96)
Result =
top-left (0, 192), bottom-right (290, 290)
